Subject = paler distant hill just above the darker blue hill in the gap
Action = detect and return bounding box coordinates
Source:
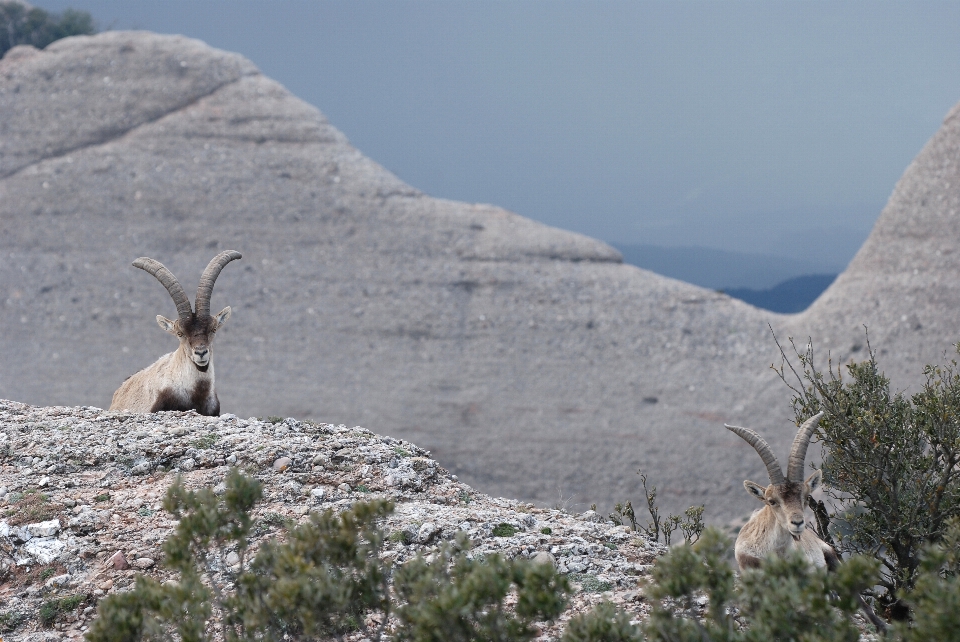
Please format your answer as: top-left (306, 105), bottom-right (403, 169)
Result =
top-left (614, 244), bottom-right (844, 290)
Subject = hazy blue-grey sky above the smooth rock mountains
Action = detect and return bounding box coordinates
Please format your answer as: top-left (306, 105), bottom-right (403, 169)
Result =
top-left (41, 0), bottom-right (960, 271)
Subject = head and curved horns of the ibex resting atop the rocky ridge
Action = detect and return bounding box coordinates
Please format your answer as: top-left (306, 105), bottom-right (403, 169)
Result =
top-left (133, 250), bottom-right (241, 372)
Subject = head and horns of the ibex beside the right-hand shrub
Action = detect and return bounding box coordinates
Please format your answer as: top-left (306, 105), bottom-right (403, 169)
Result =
top-left (724, 411), bottom-right (823, 539)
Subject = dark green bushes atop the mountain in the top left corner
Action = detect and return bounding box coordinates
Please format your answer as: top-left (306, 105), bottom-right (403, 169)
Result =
top-left (0, 2), bottom-right (97, 57)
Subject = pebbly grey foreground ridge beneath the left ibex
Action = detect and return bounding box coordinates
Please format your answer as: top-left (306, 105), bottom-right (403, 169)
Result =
top-left (0, 400), bottom-right (665, 642)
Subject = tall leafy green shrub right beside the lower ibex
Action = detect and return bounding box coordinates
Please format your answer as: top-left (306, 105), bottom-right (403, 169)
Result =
top-left (778, 341), bottom-right (960, 619)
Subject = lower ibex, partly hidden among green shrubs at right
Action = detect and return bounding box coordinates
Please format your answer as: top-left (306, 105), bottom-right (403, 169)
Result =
top-left (724, 410), bottom-right (886, 631)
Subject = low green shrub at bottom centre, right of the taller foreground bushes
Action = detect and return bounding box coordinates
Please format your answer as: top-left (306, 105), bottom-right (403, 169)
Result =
top-left (394, 537), bottom-right (570, 642)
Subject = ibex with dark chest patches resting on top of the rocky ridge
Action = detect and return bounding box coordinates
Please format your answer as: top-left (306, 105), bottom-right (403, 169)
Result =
top-left (110, 250), bottom-right (240, 416)
